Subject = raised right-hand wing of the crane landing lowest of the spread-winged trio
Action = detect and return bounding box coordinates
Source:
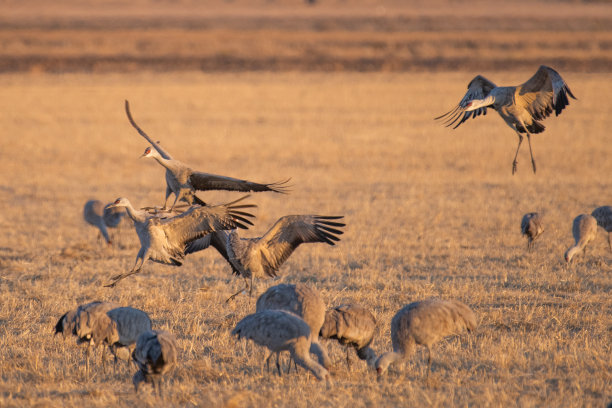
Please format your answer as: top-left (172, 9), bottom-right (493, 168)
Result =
top-left (254, 215), bottom-right (345, 277)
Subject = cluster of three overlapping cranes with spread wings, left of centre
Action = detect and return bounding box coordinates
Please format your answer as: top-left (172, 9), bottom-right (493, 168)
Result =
top-left (106, 101), bottom-right (345, 300)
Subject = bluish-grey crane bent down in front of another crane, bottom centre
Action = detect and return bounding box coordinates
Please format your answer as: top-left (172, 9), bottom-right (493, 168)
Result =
top-left (232, 310), bottom-right (330, 380)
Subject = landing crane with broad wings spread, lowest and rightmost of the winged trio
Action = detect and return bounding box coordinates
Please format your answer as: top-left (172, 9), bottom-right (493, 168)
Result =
top-left (185, 215), bottom-right (345, 301)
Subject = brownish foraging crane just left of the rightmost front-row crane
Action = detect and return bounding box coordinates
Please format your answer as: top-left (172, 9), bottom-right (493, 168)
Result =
top-left (320, 304), bottom-right (377, 368)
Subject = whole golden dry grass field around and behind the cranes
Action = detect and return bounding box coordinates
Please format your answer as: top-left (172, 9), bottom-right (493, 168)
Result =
top-left (0, 0), bottom-right (612, 406)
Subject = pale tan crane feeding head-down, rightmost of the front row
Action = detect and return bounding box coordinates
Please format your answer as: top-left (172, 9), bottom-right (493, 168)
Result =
top-left (376, 299), bottom-right (477, 376)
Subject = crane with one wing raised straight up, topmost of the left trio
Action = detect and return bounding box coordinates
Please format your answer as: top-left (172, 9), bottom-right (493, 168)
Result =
top-left (125, 101), bottom-right (289, 209)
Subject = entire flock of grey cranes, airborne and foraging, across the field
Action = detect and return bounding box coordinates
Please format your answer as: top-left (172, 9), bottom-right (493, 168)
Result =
top-left (61, 66), bottom-right (612, 395)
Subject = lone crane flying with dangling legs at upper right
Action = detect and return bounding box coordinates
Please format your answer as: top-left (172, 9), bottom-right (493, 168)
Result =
top-left (436, 65), bottom-right (576, 174)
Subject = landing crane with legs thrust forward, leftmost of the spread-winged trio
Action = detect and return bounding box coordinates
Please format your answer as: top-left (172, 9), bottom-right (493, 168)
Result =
top-left (106, 196), bottom-right (256, 287)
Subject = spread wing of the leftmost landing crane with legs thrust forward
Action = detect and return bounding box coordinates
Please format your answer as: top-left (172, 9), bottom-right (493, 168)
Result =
top-left (159, 196), bottom-right (257, 248)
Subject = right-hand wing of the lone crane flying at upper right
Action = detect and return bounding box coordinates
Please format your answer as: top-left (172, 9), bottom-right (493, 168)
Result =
top-left (514, 65), bottom-right (576, 120)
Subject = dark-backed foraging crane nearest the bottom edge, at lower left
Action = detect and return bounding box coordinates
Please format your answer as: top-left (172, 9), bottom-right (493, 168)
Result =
top-left (132, 330), bottom-right (178, 397)
